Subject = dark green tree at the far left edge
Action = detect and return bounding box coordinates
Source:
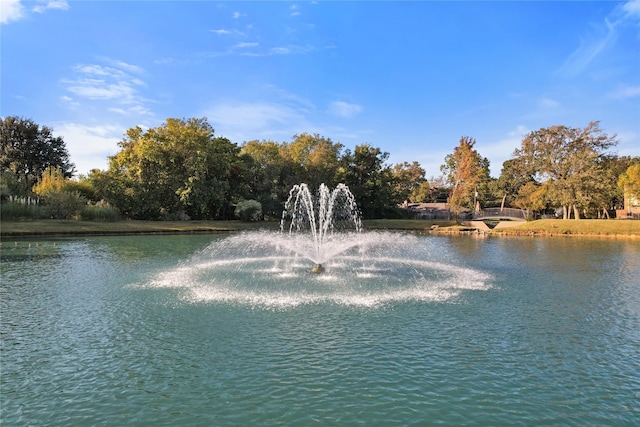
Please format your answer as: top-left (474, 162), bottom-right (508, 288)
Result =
top-left (0, 116), bottom-right (75, 196)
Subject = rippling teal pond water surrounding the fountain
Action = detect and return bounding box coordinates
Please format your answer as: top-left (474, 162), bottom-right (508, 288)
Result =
top-left (0, 233), bottom-right (640, 426)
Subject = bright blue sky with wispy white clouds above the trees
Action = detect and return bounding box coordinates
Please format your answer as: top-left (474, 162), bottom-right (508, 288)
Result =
top-left (0, 0), bottom-right (640, 177)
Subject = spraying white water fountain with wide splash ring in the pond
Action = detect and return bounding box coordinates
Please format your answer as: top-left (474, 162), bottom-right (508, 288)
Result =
top-left (150, 184), bottom-right (488, 307)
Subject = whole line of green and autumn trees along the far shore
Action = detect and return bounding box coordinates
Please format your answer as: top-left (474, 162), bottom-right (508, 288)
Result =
top-left (0, 116), bottom-right (640, 220)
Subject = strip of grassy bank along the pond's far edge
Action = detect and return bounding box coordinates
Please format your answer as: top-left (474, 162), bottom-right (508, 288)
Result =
top-left (0, 219), bottom-right (640, 240)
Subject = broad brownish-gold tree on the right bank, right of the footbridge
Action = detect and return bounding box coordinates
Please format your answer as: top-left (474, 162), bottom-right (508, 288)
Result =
top-left (514, 122), bottom-right (616, 219)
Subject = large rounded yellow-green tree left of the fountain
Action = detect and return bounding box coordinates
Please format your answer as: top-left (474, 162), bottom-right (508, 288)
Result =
top-left (106, 118), bottom-right (241, 219)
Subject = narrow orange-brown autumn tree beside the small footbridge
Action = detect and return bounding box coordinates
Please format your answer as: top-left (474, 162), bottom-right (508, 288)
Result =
top-left (440, 136), bottom-right (489, 218)
